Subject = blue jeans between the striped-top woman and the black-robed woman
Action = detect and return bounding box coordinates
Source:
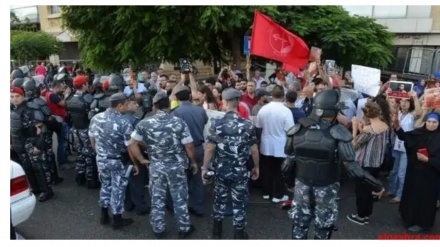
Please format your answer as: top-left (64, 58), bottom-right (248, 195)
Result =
top-left (388, 150), bottom-right (408, 198)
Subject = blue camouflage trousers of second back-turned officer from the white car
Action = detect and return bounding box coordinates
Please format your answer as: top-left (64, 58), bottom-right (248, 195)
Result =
top-left (150, 163), bottom-right (191, 233)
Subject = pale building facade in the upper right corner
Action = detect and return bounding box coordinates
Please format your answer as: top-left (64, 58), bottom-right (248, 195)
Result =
top-left (343, 5), bottom-right (440, 76)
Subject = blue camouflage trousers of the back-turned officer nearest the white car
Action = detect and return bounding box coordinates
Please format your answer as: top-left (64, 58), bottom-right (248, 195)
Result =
top-left (96, 156), bottom-right (128, 215)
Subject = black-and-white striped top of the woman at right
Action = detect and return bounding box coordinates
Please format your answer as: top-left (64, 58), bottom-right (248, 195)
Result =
top-left (354, 126), bottom-right (388, 168)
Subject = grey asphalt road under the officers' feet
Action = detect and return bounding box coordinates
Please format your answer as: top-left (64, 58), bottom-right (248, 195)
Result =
top-left (17, 162), bottom-right (440, 239)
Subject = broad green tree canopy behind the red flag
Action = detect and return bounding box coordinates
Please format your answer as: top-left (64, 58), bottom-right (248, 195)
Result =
top-left (62, 6), bottom-right (392, 70)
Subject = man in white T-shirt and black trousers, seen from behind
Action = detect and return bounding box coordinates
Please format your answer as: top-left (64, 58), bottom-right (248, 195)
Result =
top-left (256, 85), bottom-right (295, 203)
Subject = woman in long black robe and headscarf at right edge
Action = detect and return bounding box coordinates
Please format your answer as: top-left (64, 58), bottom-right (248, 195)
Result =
top-left (395, 112), bottom-right (440, 232)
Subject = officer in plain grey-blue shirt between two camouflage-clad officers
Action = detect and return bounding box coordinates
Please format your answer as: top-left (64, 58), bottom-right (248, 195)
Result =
top-left (171, 85), bottom-right (208, 216)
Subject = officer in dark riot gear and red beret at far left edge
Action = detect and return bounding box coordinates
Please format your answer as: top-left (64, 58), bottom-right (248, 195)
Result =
top-left (11, 87), bottom-right (53, 202)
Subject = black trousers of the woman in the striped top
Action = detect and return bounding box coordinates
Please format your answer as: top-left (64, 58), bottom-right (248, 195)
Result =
top-left (355, 167), bottom-right (380, 218)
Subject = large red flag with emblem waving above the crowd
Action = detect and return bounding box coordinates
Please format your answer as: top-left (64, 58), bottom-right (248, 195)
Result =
top-left (251, 10), bottom-right (310, 68)
